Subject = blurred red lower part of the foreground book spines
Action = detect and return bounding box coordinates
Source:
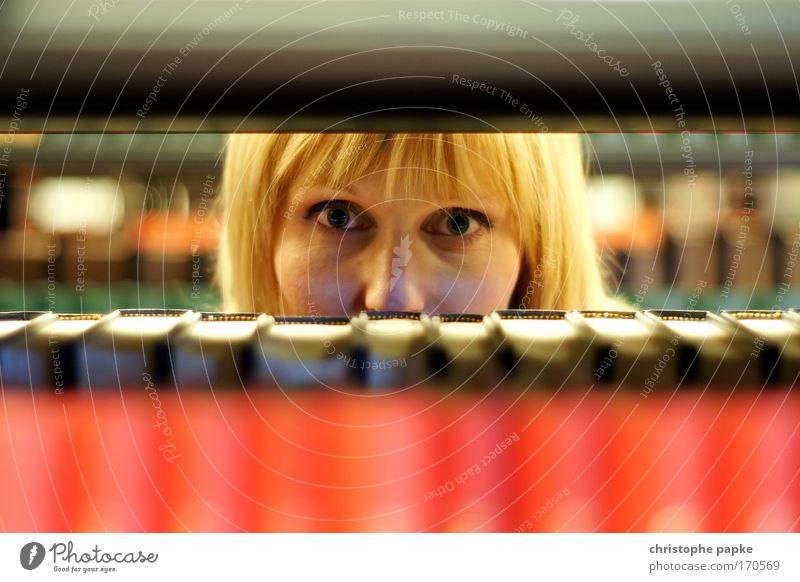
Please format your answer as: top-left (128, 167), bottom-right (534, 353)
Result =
top-left (0, 388), bottom-right (800, 532)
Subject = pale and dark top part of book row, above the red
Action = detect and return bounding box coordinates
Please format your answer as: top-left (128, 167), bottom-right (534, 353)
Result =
top-left (0, 309), bottom-right (800, 397)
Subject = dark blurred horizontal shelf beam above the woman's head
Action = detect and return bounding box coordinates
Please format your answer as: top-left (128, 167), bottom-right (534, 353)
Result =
top-left (0, 0), bottom-right (800, 132)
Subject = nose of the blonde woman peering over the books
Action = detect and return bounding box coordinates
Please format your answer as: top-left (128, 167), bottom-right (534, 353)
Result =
top-left (362, 234), bottom-right (430, 318)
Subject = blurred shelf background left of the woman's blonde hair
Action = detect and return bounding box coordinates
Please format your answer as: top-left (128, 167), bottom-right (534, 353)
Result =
top-left (0, 134), bottom-right (225, 313)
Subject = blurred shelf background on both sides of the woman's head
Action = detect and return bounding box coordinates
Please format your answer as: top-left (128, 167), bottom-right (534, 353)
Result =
top-left (0, 133), bottom-right (800, 313)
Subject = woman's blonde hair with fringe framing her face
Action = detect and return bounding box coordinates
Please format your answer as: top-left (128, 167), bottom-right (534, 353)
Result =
top-left (217, 133), bottom-right (623, 314)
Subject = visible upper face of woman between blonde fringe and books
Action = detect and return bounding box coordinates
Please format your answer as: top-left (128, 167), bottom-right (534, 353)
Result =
top-left (273, 164), bottom-right (520, 316)
